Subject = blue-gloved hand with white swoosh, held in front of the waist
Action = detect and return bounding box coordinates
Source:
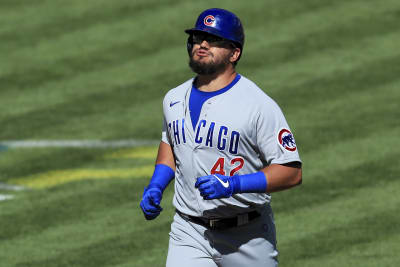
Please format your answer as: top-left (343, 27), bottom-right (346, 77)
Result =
top-left (195, 174), bottom-right (235, 200)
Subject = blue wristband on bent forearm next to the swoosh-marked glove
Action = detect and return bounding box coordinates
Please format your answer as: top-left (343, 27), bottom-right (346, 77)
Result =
top-left (232, 171), bottom-right (267, 194)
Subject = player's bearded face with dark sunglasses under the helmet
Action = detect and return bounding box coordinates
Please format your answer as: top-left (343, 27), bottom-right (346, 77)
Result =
top-left (189, 33), bottom-right (235, 75)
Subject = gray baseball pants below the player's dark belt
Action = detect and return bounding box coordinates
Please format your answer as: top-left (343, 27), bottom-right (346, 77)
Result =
top-left (166, 206), bottom-right (278, 267)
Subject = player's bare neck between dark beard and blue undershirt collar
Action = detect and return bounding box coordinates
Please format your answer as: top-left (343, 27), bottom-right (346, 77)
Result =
top-left (195, 68), bottom-right (236, 92)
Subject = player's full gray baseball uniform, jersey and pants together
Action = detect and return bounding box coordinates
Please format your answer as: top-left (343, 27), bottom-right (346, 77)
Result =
top-left (162, 74), bottom-right (300, 266)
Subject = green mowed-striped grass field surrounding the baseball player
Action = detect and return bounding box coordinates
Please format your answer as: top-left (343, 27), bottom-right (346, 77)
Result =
top-left (0, 0), bottom-right (400, 267)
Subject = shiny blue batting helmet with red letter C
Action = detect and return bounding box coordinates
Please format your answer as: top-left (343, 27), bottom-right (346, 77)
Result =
top-left (185, 8), bottom-right (244, 60)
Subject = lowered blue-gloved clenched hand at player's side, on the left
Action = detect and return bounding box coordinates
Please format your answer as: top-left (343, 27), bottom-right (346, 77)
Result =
top-left (140, 186), bottom-right (162, 220)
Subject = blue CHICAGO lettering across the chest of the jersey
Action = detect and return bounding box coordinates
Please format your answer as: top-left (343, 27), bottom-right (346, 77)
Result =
top-left (168, 119), bottom-right (240, 155)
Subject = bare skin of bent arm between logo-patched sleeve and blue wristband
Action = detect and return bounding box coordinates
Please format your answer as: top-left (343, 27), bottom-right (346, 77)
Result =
top-left (261, 162), bottom-right (302, 193)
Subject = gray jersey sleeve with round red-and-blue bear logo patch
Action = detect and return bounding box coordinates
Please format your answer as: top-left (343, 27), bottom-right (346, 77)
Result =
top-left (255, 99), bottom-right (301, 165)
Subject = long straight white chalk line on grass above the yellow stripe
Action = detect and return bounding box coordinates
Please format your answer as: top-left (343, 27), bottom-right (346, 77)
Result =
top-left (0, 139), bottom-right (160, 149)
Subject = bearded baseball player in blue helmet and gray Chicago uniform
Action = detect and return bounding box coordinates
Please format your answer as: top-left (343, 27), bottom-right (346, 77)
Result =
top-left (140, 8), bottom-right (302, 267)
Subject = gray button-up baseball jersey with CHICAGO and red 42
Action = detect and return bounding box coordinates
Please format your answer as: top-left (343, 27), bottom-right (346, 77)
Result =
top-left (162, 76), bottom-right (300, 218)
